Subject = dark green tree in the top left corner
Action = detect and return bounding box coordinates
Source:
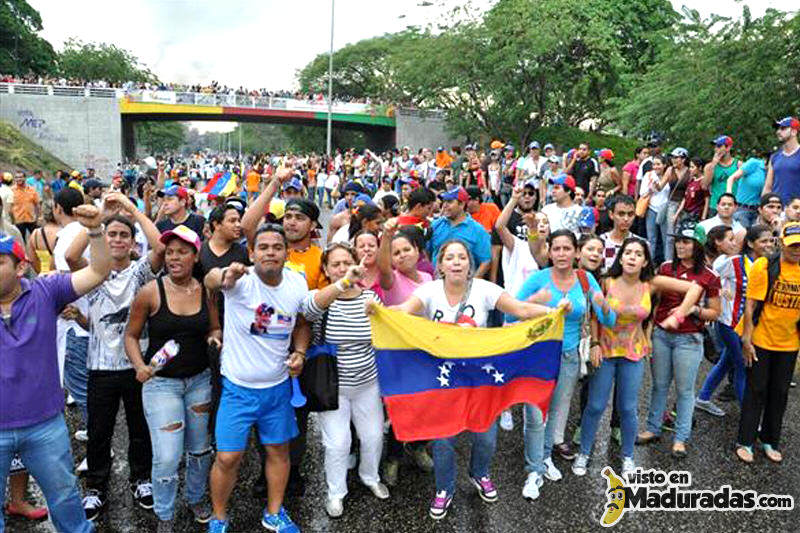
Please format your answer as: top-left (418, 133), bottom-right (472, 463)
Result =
top-left (0, 0), bottom-right (56, 75)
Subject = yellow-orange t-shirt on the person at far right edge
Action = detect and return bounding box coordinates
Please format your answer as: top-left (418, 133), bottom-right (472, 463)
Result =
top-left (747, 257), bottom-right (800, 352)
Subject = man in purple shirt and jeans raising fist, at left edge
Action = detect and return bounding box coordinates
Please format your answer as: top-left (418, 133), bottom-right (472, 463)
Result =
top-left (0, 201), bottom-right (111, 533)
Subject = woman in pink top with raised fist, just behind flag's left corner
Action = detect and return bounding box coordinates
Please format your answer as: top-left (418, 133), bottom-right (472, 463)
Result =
top-left (377, 220), bottom-right (433, 306)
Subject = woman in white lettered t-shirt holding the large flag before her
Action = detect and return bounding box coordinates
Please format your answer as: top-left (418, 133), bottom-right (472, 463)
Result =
top-left (388, 240), bottom-right (554, 520)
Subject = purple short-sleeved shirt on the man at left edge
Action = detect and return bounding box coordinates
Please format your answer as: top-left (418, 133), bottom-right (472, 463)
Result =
top-left (0, 274), bottom-right (78, 430)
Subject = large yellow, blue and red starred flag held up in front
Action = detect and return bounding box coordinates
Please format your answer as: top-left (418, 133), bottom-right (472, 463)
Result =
top-left (371, 306), bottom-right (564, 441)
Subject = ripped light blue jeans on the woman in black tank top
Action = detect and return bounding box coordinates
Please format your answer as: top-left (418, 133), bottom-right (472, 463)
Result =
top-left (142, 369), bottom-right (211, 520)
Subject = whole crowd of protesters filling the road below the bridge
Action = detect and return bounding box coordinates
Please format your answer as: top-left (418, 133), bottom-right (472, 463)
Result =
top-left (0, 117), bottom-right (800, 533)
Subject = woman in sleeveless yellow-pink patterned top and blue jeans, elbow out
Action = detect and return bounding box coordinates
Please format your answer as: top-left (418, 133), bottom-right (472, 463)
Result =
top-left (573, 237), bottom-right (703, 477)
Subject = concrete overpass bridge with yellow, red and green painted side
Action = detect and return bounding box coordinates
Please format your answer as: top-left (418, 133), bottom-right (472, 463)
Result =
top-left (0, 83), bottom-right (454, 176)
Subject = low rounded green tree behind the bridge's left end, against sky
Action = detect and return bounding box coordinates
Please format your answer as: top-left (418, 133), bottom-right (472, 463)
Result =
top-left (58, 38), bottom-right (156, 84)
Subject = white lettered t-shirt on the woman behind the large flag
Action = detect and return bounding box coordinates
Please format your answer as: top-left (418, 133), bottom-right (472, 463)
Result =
top-left (414, 278), bottom-right (504, 328)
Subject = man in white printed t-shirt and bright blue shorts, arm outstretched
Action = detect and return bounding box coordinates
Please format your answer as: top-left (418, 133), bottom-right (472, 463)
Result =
top-left (205, 224), bottom-right (311, 531)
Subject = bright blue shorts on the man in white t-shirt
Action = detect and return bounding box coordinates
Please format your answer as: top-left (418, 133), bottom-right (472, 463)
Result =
top-left (214, 376), bottom-right (300, 452)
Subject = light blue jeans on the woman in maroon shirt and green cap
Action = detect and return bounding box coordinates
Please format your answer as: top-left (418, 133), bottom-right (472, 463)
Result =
top-left (647, 327), bottom-right (703, 443)
